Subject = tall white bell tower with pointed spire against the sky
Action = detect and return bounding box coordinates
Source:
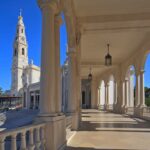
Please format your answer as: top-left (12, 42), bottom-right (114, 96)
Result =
top-left (11, 11), bottom-right (28, 96)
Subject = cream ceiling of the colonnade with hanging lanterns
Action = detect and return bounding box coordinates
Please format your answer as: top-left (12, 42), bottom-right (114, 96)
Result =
top-left (73, 0), bottom-right (150, 76)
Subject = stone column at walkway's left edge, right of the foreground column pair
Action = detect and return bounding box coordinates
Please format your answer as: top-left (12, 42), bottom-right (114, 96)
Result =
top-left (67, 49), bottom-right (79, 130)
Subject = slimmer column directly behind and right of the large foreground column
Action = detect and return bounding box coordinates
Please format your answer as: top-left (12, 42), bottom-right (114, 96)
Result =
top-left (55, 15), bottom-right (62, 114)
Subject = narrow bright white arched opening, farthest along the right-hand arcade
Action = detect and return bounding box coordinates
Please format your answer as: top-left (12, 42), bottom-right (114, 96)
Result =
top-left (99, 80), bottom-right (105, 109)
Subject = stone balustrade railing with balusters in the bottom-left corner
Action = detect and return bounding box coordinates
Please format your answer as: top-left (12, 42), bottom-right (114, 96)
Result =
top-left (0, 124), bottom-right (45, 150)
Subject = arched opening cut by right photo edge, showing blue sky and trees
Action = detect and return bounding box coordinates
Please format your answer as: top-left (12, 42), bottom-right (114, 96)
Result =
top-left (144, 53), bottom-right (150, 107)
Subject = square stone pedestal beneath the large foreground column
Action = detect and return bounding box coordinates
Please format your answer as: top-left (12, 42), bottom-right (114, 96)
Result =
top-left (35, 114), bottom-right (66, 150)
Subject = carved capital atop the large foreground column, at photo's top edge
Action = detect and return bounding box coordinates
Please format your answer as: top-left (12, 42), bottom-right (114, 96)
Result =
top-left (38, 0), bottom-right (59, 13)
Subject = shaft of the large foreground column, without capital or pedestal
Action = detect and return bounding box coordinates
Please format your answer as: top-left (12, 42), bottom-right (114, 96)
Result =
top-left (40, 7), bottom-right (56, 114)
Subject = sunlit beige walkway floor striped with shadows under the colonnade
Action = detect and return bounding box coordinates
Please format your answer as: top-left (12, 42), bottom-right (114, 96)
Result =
top-left (67, 109), bottom-right (150, 150)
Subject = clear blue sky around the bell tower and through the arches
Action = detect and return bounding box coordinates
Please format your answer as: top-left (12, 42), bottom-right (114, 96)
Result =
top-left (0, 0), bottom-right (150, 90)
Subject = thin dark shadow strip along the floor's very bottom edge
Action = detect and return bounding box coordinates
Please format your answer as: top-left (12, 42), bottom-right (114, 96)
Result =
top-left (66, 146), bottom-right (137, 150)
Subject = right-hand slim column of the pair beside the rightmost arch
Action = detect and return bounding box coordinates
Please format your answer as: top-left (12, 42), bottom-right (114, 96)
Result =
top-left (140, 70), bottom-right (145, 107)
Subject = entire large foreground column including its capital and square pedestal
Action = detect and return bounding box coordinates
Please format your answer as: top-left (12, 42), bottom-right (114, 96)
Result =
top-left (35, 0), bottom-right (66, 150)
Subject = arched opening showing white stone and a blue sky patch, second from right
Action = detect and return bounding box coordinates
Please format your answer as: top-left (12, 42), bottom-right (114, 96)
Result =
top-left (125, 65), bottom-right (136, 114)
